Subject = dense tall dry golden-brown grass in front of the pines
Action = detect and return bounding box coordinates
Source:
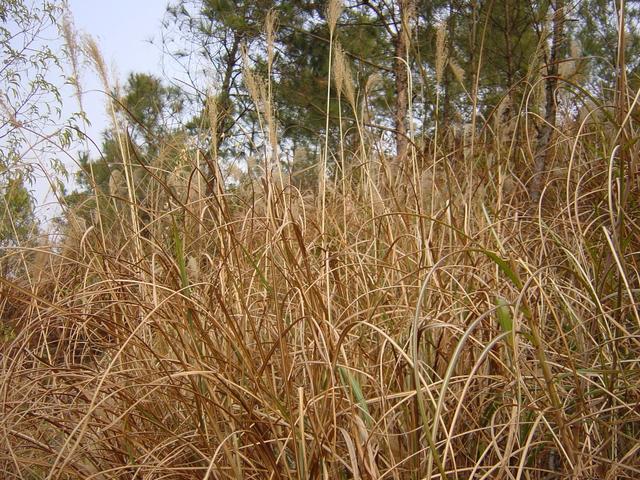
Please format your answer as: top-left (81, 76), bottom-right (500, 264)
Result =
top-left (0, 11), bottom-right (640, 480)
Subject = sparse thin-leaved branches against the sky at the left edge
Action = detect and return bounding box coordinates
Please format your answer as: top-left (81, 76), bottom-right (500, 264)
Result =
top-left (0, 0), bottom-right (62, 253)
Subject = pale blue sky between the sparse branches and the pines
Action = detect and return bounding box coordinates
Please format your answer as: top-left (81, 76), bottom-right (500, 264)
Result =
top-left (35, 0), bottom-right (172, 218)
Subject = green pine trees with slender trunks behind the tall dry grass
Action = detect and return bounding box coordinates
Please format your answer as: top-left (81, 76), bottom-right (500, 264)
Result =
top-left (67, 0), bottom-right (640, 206)
